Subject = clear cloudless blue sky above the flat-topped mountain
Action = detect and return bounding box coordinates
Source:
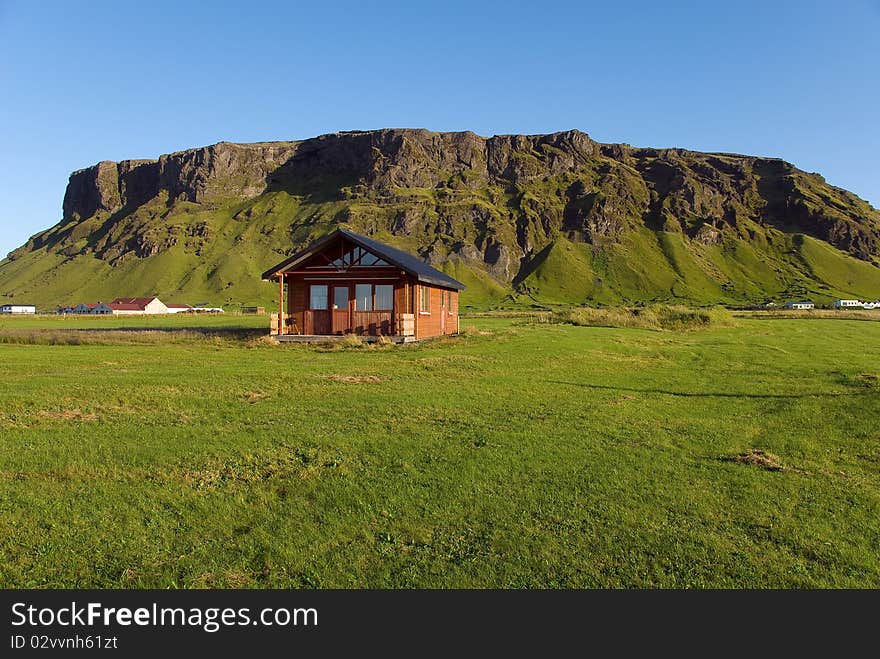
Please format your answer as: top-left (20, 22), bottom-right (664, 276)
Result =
top-left (0, 0), bottom-right (880, 255)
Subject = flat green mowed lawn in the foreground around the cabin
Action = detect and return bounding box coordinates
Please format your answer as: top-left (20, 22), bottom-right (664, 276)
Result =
top-left (0, 319), bottom-right (880, 588)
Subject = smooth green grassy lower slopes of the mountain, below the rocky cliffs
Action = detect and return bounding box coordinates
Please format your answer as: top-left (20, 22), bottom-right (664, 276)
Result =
top-left (0, 193), bottom-right (880, 309)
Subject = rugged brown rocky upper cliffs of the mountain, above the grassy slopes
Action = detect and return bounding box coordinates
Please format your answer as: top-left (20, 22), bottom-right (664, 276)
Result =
top-left (6, 130), bottom-right (880, 308)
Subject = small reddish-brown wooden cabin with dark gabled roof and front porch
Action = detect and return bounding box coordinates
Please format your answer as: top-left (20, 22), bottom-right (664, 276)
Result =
top-left (263, 229), bottom-right (465, 341)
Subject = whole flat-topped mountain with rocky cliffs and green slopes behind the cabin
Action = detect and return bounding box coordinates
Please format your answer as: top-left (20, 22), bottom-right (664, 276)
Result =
top-left (0, 129), bottom-right (880, 307)
